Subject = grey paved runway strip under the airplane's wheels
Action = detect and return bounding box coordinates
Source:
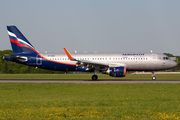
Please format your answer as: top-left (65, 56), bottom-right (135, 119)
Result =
top-left (0, 79), bottom-right (180, 84)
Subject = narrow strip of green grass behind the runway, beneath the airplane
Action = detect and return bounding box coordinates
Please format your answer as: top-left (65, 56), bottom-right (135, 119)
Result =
top-left (0, 74), bottom-right (180, 80)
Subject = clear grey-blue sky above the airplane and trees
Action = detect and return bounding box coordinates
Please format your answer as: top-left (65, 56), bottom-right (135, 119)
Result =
top-left (0, 0), bottom-right (180, 56)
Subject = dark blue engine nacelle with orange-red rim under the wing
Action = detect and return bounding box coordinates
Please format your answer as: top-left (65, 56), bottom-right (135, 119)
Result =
top-left (106, 67), bottom-right (126, 77)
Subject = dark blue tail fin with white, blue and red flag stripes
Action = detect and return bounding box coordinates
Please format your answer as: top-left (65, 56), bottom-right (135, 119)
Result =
top-left (7, 26), bottom-right (38, 54)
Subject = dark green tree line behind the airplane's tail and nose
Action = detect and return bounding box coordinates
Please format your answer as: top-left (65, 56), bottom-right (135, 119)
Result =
top-left (0, 50), bottom-right (180, 74)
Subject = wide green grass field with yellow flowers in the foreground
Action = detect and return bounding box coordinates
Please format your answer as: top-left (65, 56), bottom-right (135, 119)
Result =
top-left (0, 83), bottom-right (180, 120)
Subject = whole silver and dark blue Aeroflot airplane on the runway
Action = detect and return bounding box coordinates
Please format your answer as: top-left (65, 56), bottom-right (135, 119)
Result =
top-left (3, 26), bottom-right (177, 80)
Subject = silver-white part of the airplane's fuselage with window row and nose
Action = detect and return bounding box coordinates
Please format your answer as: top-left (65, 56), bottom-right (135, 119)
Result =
top-left (41, 53), bottom-right (176, 71)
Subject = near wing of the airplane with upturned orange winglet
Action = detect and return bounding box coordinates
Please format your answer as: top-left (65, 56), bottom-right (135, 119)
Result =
top-left (64, 48), bottom-right (109, 69)
